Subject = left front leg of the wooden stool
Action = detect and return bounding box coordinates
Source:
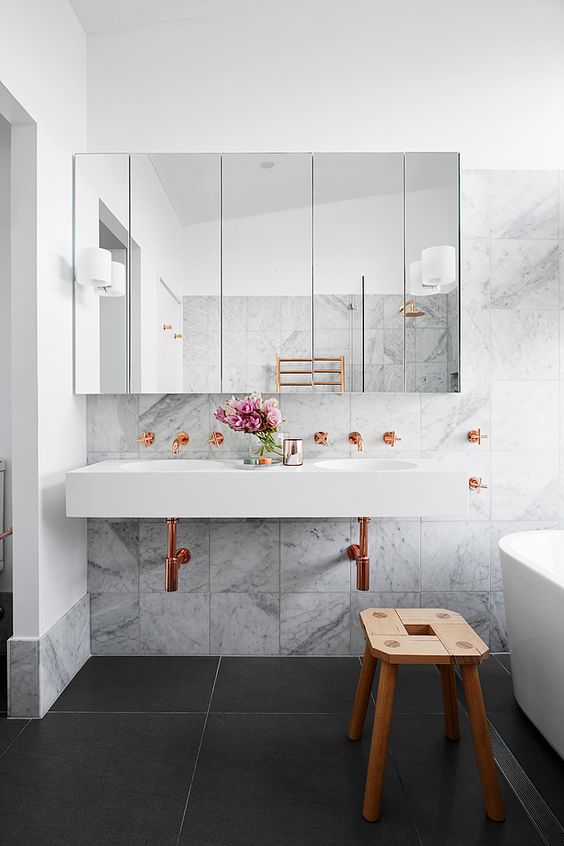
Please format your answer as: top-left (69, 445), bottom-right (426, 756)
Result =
top-left (362, 661), bottom-right (398, 822)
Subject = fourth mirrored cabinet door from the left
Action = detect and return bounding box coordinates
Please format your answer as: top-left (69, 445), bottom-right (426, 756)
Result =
top-left (313, 153), bottom-right (404, 391)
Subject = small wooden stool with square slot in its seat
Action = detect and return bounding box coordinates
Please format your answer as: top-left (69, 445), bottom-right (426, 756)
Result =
top-left (347, 608), bottom-right (505, 822)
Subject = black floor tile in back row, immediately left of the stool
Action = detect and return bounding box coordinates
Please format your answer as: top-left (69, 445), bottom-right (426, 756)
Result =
top-left (211, 658), bottom-right (360, 714)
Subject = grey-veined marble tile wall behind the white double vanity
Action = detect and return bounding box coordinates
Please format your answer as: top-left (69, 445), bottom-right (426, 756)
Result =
top-left (88, 171), bottom-right (564, 655)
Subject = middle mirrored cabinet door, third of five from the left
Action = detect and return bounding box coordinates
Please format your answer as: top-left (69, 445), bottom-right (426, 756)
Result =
top-left (222, 153), bottom-right (312, 393)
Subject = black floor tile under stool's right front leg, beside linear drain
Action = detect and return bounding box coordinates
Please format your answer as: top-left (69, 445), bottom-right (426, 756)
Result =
top-left (386, 714), bottom-right (541, 846)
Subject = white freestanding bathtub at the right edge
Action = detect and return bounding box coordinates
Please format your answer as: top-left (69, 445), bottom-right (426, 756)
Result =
top-left (499, 529), bottom-right (564, 758)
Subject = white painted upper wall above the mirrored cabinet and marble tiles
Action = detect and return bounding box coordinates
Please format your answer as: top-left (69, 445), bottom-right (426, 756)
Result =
top-left (88, 0), bottom-right (564, 169)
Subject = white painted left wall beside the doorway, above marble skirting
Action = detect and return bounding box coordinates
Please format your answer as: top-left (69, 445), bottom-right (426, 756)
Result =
top-left (0, 0), bottom-right (86, 637)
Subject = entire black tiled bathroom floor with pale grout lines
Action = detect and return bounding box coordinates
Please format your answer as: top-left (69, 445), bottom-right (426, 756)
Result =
top-left (0, 657), bottom-right (564, 846)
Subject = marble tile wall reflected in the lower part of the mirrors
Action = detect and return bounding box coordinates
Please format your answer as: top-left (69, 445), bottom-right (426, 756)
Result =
top-left (182, 294), bottom-right (452, 393)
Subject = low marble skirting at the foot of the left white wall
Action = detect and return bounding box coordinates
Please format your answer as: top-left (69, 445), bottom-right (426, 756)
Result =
top-left (8, 594), bottom-right (90, 717)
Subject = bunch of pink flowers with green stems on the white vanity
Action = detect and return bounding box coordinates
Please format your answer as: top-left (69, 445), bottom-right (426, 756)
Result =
top-left (213, 393), bottom-right (282, 455)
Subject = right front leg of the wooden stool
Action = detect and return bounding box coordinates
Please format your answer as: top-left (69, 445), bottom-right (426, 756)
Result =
top-left (460, 664), bottom-right (505, 822)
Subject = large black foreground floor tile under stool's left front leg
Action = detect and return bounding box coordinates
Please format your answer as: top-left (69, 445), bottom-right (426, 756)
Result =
top-left (180, 714), bottom-right (421, 846)
